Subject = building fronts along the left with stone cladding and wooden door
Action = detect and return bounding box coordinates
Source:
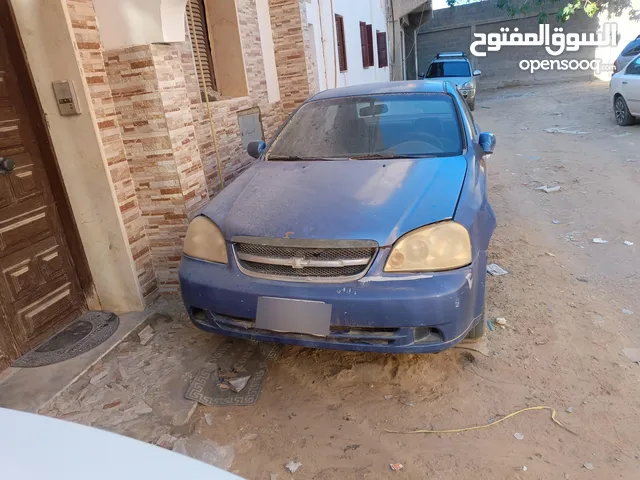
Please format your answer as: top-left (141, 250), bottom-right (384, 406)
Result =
top-left (0, 0), bottom-right (364, 367)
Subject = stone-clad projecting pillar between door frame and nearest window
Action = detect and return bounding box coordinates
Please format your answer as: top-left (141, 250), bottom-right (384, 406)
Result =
top-left (105, 44), bottom-right (209, 292)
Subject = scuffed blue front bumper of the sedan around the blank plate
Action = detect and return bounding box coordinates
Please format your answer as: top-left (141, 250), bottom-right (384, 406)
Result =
top-left (180, 252), bottom-right (486, 353)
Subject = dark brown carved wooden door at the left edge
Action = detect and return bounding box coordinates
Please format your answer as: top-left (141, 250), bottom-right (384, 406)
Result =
top-left (0, 16), bottom-right (86, 368)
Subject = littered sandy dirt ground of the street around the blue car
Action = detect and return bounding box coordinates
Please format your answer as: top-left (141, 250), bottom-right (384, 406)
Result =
top-left (44, 83), bottom-right (640, 480)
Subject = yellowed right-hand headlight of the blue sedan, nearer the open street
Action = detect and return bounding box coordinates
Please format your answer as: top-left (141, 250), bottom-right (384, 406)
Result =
top-left (384, 221), bottom-right (471, 272)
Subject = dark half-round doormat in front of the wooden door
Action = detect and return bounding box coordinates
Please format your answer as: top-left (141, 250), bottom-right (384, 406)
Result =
top-left (12, 312), bottom-right (120, 368)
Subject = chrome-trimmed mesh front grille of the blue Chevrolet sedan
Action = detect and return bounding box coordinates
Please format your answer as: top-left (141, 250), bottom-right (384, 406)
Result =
top-left (233, 239), bottom-right (377, 282)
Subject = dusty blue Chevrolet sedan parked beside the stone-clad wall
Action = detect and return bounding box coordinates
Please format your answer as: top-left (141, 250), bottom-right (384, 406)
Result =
top-left (180, 81), bottom-right (496, 353)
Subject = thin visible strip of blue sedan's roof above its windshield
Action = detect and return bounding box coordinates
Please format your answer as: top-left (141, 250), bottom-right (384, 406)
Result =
top-left (307, 80), bottom-right (452, 102)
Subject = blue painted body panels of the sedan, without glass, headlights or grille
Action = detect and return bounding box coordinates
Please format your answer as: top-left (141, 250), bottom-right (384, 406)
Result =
top-left (180, 81), bottom-right (496, 353)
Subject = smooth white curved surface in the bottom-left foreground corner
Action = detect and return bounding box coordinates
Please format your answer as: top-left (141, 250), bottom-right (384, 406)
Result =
top-left (0, 408), bottom-right (240, 480)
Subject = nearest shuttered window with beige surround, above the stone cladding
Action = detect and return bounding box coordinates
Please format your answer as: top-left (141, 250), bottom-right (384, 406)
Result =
top-left (186, 0), bottom-right (248, 100)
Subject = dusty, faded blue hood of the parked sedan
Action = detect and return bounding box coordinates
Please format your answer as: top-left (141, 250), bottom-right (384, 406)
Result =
top-left (208, 156), bottom-right (467, 245)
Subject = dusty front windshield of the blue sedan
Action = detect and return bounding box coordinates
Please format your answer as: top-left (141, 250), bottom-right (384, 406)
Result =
top-left (267, 93), bottom-right (462, 161)
